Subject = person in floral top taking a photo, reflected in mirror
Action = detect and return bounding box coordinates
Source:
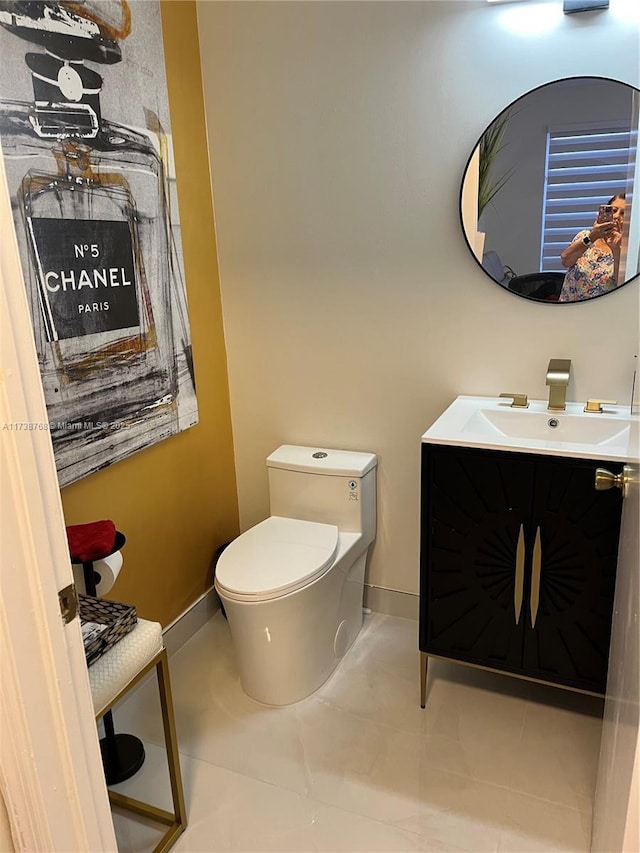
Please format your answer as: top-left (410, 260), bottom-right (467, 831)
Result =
top-left (559, 193), bottom-right (626, 302)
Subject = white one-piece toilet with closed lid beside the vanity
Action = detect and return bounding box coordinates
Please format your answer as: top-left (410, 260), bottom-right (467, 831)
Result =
top-left (215, 445), bottom-right (377, 705)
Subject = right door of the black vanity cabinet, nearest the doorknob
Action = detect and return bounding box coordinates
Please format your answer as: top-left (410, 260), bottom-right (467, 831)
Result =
top-left (523, 459), bottom-right (622, 693)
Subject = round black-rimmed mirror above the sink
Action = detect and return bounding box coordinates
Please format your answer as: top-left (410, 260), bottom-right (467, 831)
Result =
top-left (460, 77), bottom-right (640, 304)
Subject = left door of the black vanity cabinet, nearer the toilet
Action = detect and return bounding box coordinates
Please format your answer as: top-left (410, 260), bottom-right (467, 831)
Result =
top-left (420, 445), bottom-right (535, 672)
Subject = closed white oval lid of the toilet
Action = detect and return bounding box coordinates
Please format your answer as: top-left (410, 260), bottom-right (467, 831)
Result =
top-left (216, 516), bottom-right (338, 601)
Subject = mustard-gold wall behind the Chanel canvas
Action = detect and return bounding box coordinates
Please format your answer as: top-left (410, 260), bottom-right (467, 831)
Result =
top-left (62, 0), bottom-right (238, 625)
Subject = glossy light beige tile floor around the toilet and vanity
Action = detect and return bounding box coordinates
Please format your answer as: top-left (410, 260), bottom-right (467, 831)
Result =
top-left (107, 613), bottom-right (602, 853)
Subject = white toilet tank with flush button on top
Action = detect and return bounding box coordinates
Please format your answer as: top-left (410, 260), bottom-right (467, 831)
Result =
top-left (267, 444), bottom-right (377, 544)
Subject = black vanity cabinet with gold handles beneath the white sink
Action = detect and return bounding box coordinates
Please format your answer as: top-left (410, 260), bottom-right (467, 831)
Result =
top-left (420, 444), bottom-right (623, 704)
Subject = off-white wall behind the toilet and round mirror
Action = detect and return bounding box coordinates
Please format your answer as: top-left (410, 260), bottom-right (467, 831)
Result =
top-left (199, 0), bottom-right (640, 593)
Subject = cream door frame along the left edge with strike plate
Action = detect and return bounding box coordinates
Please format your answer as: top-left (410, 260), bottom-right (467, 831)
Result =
top-left (0, 149), bottom-right (117, 853)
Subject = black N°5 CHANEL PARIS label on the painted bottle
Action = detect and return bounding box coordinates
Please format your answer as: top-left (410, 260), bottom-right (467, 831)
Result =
top-left (29, 218), bottom-right (139, 341)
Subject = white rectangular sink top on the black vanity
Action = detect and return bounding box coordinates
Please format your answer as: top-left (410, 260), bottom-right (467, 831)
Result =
top-left (422, 396), bottom-right (640, 461)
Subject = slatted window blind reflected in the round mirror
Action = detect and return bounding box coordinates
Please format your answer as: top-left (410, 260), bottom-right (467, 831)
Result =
top-left (540, 126), bottom-right (637, 272)
